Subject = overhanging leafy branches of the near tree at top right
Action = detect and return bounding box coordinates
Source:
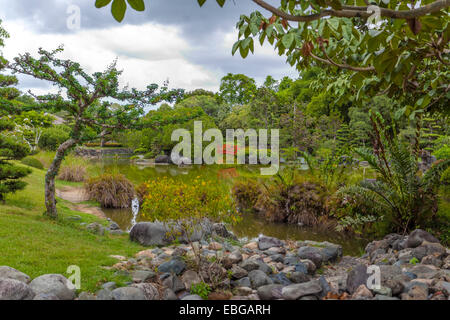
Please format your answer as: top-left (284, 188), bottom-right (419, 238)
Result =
top-left (96, 0), bottom-right (450, 116)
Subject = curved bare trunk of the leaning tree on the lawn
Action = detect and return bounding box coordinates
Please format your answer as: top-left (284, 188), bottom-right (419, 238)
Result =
top-left (45, 139), bottom-right (77, 219)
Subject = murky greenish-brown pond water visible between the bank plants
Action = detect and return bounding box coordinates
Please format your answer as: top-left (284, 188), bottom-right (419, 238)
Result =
top-left (95, 158), bottom-right (368, 255)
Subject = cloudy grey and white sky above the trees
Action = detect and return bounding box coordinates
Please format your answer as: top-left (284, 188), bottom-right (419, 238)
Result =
top-left (0, 0), bottom-right (297, 94)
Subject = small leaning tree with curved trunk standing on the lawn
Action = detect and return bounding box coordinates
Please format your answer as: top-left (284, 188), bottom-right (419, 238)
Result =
top-left (7, 48), bottom-right (182, 218)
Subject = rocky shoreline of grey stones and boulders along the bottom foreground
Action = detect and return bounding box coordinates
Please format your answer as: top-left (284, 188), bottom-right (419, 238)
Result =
top-left (0, 228), bottom-right (450, 300)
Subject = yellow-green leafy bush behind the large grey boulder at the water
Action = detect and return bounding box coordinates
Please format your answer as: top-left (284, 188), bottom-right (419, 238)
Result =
top-left (140, 176), bottom-right (239, 223)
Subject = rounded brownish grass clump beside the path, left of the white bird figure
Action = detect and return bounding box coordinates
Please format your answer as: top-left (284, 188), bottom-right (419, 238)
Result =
top-left (84, 173), bottom-right (135, 208)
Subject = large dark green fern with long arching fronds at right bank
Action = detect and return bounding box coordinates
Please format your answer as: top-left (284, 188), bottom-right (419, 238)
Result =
top-left (338, 116), bottom-right (450, 233)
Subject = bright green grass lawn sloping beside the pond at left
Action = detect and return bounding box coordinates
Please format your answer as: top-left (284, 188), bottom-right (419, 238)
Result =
top-left (0, 164), bottom-right (143, 292)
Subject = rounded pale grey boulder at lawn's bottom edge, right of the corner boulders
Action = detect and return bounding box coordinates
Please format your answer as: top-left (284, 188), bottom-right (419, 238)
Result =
top-left (30, 274), bottom-right (75, 300)
